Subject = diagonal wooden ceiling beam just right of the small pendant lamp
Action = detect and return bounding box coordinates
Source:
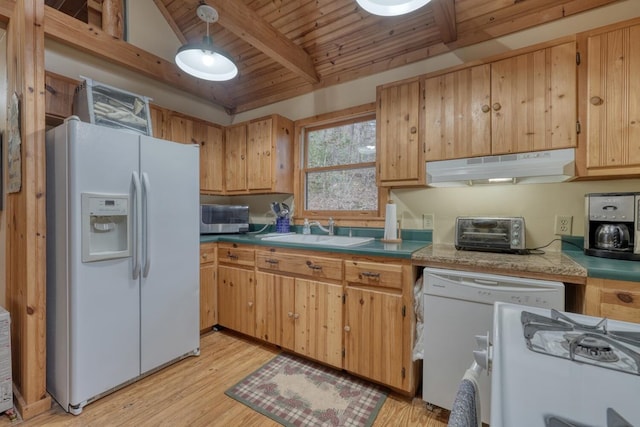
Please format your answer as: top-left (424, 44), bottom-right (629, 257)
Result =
top-left (207, 0), bottom-right (319, 83)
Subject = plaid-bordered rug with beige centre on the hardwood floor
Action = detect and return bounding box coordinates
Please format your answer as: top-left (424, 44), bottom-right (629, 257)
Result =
top-left (225, 353), bottom-right (387, 427)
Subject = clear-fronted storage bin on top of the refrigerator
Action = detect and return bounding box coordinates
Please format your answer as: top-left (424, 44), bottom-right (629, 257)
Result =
top-left (73, 78), bottom-right (153, 136)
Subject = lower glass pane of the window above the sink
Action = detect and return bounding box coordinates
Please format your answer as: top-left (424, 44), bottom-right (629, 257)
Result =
top-left (306, 167), bottom-right (378, 211)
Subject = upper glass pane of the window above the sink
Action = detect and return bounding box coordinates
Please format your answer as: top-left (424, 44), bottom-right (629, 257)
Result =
top-left (307, 120), bottom-right (376, 168)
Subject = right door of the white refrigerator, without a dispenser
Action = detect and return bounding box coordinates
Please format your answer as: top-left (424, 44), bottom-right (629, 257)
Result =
top-left (140, 136), bottom-right (200, 373)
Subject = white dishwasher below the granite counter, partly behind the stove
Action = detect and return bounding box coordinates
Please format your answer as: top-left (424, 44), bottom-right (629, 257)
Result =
top-left (422, 267), bottom-right (564, 423)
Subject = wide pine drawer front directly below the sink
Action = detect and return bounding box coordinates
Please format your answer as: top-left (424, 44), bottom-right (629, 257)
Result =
top-left (256, 251), bottom-right (342, 280)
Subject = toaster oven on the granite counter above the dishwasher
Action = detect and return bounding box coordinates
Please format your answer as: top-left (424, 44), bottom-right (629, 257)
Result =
top-left (455, 216), bottom-right (527, 254)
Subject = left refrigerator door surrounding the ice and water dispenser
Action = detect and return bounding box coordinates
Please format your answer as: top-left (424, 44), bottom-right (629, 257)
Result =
top-left (63, 120), bottom-right (140, 409)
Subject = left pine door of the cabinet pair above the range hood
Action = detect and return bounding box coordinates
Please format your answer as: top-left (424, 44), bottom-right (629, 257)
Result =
top-left (424, 64), bottom-right (491, 160)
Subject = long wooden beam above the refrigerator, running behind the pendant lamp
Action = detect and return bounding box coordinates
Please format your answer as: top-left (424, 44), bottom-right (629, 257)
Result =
top-left (44, 6), bottom-right (235, 111)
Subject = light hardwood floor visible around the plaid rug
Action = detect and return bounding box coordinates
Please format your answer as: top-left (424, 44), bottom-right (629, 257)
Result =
top-left (5, 331), bottom-right (448, 427)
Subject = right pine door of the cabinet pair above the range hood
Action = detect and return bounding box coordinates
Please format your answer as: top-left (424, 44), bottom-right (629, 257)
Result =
top-left (491, 42), bottom-right (577, 154)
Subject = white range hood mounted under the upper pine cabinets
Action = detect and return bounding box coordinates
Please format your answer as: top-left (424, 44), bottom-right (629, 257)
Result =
top-left (427, 148), bottom-right (575, 187)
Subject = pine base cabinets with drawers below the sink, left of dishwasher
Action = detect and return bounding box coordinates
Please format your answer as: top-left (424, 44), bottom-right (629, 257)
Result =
top-left (218, 243), bottom-right (418, 395)
